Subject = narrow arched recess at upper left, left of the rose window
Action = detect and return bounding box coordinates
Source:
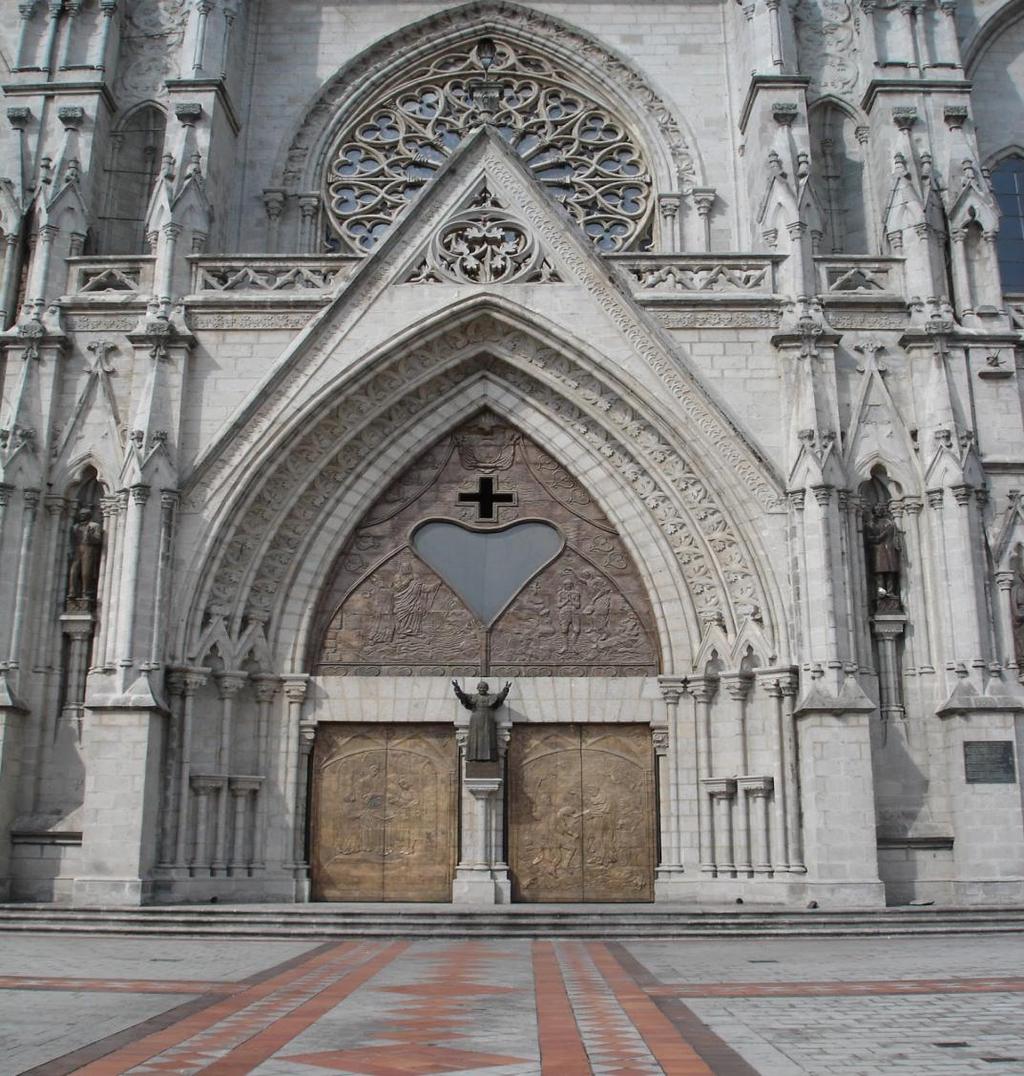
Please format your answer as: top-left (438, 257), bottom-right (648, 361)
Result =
top-left (102, 104), bottom-right (167, 254)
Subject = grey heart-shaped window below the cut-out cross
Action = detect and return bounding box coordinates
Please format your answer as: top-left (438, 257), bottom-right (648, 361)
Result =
top-left (412, 520), bottom-right (565, 625)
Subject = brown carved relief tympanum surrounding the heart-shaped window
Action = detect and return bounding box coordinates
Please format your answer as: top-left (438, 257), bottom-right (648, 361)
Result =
top-left (315, 412), bottom-right (657, 677)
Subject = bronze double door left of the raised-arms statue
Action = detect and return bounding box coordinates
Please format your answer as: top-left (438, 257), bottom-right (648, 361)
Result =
top-left (312, 724), bottom-right (458, 901)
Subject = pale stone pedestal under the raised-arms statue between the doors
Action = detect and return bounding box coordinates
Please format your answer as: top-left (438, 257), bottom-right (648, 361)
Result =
top-left (452, 767), bottom-right (511, 904)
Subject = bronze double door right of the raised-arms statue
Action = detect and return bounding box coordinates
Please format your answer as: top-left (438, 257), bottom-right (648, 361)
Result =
top-left (509, 724), bottom-right (655, 902)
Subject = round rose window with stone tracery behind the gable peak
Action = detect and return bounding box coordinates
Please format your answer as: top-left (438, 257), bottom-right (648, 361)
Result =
top-left (325, 40), bottom-right (652, 254)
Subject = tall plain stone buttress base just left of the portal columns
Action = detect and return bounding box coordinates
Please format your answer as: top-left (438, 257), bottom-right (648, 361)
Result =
top-left (72, 707), bottom-right (165, 907)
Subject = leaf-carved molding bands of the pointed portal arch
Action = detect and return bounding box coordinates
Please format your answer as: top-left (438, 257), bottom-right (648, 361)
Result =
top-left (194, 318), bottom-right (765, 654)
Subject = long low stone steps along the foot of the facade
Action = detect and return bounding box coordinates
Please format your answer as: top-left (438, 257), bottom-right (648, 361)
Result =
top-left (0, 905), bottom-right (1024, 938)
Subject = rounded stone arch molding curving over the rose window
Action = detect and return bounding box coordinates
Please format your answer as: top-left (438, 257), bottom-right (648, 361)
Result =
top-left (272, 0), bottom-right (705, 244)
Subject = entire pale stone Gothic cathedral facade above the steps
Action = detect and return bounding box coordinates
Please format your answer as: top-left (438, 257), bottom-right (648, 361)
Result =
top-left (0, 0), bottom-right (1024, 907)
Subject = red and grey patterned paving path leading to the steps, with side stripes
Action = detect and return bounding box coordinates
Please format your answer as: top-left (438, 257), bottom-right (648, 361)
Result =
top-left (10, 939), bottom-right (1024, 1076)
